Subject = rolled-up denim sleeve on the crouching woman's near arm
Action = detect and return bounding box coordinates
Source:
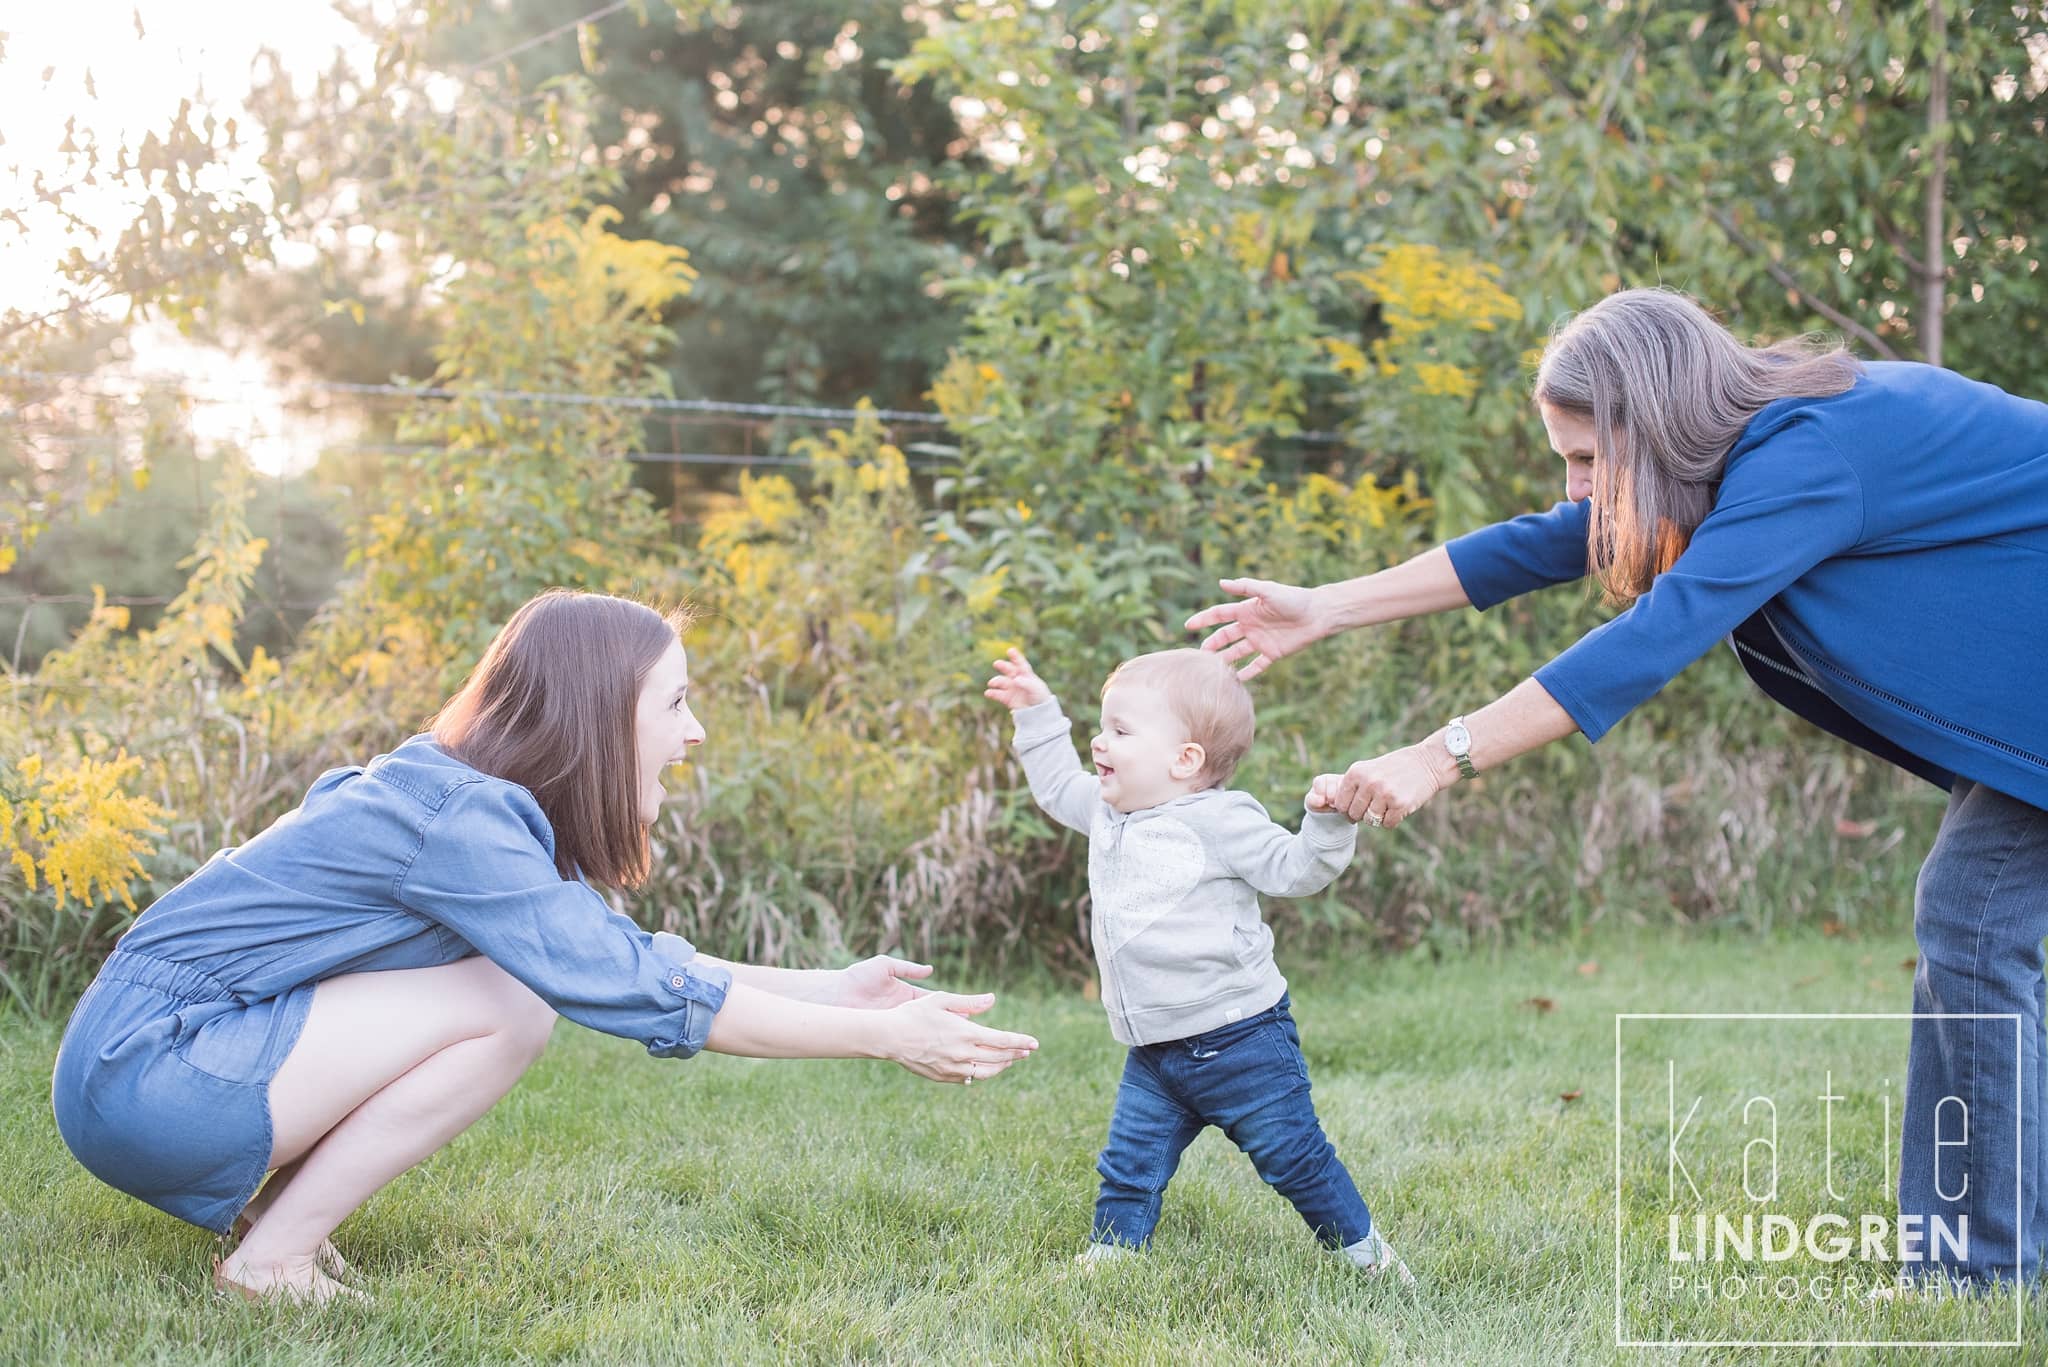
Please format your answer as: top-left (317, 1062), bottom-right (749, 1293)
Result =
top-left (397, 781), bottom-right (731, 1058)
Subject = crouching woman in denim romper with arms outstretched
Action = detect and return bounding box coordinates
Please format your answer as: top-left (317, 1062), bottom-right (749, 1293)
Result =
top-left (53, 592), bottom-right (1038, 1299)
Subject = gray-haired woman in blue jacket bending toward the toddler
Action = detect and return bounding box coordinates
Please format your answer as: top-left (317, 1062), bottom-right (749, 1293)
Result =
top-left (1188, 289), bottom-right (2048, 1279)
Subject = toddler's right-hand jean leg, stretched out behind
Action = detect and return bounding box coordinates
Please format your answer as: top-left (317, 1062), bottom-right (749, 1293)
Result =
top-left (1184, 1006), bottom-right (1372, 1248)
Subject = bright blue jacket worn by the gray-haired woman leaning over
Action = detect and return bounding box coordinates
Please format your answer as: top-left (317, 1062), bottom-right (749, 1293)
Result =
top-left (1446, 363), bottom-right (2048, 807)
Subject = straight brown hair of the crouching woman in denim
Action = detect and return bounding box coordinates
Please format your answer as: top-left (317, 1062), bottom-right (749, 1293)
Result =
top-left (430, 588), bottom-right (688, 887)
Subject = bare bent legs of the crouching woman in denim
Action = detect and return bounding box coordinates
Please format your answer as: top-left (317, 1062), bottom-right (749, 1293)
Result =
top-left (221, 957), bottom-right (555, 1297)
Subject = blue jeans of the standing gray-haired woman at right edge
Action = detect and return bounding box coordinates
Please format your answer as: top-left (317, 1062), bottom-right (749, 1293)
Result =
top-left (1898, 779), bottom-right (2048, 1281)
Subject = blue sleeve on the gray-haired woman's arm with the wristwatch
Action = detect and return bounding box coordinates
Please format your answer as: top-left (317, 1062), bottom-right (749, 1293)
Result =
top-left (1536, 422), bottom-right (1864, 740)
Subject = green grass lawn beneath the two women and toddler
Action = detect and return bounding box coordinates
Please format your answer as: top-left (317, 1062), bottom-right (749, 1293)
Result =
top-left (0, 933), bottom-right (2048, 1363)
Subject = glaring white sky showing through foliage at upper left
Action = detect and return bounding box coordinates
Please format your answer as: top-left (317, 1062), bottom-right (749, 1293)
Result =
top-left (0, 0), bottom-right (371, 469)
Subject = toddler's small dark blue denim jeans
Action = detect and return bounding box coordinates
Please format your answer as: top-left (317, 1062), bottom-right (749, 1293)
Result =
top-left (1092, 996), bottom-right (1372, 1248)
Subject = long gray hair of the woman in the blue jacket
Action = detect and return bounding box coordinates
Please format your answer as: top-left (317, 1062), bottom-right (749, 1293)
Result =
top-left (1536, 287), bottom-right (1862, 603)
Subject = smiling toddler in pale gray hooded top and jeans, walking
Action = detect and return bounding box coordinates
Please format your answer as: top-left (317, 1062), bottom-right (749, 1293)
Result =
top-left (987, 650), bottom-right (1413, 1285)
